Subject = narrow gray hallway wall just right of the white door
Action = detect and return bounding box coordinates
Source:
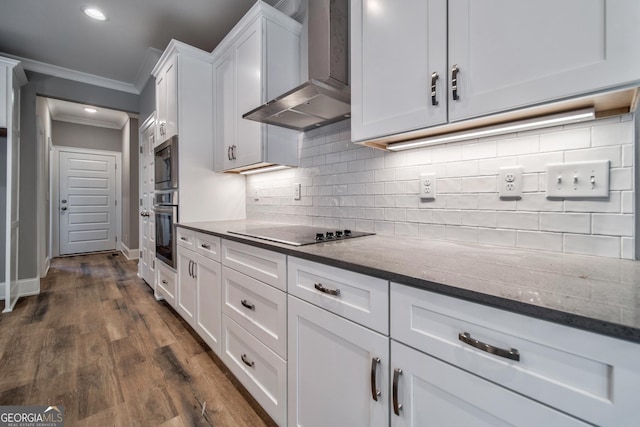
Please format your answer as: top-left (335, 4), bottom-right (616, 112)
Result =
top-left (122, 119), bottom-right (140, 249)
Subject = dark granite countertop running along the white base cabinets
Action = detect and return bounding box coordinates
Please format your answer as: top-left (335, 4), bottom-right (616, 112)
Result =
top-left (179, 220), bottom-right (640, 343)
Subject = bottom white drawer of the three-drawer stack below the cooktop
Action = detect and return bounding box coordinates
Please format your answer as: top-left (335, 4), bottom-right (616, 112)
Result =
top-left (222, 315), bottom-right (287, 426)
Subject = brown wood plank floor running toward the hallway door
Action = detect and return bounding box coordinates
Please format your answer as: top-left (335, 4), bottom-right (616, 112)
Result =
top-left (0, 254), bottom-right (275, 427)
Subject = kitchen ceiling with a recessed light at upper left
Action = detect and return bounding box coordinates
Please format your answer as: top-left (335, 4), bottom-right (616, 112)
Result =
top-left (0, 0), bottom-right (299, 93)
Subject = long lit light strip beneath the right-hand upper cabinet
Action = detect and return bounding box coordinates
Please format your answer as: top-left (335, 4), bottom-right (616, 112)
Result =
top-left (387, 108), bottom-right (596, 151)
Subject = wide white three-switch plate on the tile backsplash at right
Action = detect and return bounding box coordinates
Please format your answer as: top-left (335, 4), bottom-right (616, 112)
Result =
top-left (547, 160), bottom-right (609, 199)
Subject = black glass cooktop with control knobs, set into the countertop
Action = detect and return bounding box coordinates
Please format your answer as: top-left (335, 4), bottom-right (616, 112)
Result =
top-left (228, 225), bottom-right (374, 246)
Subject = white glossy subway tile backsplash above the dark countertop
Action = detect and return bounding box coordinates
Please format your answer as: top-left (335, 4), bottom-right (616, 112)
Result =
top-left (247, 114), bottom-right (637, 259)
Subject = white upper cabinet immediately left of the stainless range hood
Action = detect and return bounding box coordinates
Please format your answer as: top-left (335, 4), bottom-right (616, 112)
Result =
top-left (213, 2), bottom-right (301, 171)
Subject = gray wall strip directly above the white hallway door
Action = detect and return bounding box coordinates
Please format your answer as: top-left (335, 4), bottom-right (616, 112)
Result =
top-left (51, 120), bottom-right (123, 152)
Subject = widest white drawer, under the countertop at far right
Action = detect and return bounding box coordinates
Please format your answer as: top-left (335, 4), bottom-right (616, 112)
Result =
top-left (391, 283), bottom-right (640, 425)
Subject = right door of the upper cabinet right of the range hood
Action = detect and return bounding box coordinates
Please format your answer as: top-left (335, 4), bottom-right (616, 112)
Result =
top-left (448, 0), bottom-right (640, 121)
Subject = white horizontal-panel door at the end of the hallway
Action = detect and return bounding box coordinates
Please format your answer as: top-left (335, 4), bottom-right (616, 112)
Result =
top-left (58, 151), bottom-right (117, 255)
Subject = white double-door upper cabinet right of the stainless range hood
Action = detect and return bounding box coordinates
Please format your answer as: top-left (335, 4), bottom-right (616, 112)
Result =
top-left (351, 0), bottom-right (640, 141)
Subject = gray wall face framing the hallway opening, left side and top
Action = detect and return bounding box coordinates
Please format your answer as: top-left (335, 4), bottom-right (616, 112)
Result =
top-left (18, 71), bottom-right (140, 279)
